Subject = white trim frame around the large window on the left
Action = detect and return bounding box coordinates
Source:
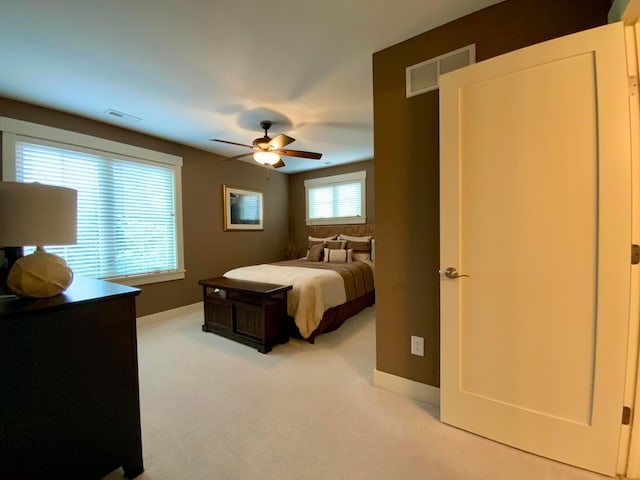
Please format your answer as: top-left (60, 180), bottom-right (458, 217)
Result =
top-left (0, 117), bottom-right (186, 286)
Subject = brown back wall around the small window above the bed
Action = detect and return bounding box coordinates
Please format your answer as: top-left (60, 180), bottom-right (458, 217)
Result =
top-left (289, 160), bottom-right (376, 257)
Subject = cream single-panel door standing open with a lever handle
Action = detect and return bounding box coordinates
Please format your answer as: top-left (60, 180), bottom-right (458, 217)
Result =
top-left (440, 24), bottom-right (631, 475)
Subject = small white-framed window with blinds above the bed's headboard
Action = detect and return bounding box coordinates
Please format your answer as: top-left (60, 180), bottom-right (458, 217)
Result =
top-left (304, 171), bottom-right (367, 225)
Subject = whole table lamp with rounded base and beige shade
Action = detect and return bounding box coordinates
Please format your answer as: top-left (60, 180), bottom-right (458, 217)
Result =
top-left (0, 182), bottom-right (78, 298)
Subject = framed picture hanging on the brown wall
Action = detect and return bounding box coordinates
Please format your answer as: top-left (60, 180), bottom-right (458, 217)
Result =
top-left (222, 185), bottom-right (264, 232)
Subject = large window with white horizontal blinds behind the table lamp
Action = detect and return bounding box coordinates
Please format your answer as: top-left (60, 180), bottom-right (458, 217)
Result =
top-left (3, 116), bottom-right (184, 285)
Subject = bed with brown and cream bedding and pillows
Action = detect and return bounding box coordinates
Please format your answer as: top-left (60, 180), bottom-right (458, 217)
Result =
top-left (224, 228), bottom-right (375, 343)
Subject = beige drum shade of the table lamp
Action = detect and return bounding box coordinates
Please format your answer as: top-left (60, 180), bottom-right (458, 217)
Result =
top-left (0, 182), bottom-right (77, 247)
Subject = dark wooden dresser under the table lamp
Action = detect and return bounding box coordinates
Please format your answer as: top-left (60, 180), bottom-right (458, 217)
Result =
top-left (0, 278), bottom-right (143, 480)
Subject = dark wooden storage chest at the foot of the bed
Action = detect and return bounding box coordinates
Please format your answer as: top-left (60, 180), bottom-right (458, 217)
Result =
top-left (198, 277), bottom-right (293, 353)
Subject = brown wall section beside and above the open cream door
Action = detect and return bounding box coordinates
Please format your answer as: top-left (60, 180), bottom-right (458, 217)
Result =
top-left (373, 0), bottom-right (610, 386)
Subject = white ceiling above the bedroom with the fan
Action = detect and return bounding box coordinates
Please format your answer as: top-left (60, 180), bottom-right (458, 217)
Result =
top-left (0, 0), bottom-right (501, 173)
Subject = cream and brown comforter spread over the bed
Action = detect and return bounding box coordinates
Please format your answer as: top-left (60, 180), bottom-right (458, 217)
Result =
top-left (224, 261), bottom-right (373, 338)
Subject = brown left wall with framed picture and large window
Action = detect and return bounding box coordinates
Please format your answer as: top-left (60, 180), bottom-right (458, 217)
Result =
top-left (0, 97), bottom-right (289, 316)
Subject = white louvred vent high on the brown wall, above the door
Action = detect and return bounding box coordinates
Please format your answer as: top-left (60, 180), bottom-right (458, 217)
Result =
top-left (407, 43), bottom-right (476, 98)
